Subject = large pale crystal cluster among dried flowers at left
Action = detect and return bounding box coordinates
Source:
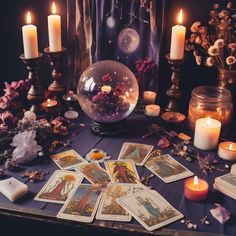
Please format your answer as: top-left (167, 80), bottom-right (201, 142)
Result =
top-left (11, 130), bottom-right (42, 164)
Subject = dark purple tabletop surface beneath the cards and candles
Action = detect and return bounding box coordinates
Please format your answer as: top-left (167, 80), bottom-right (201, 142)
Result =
top-left (0, 114), bottom-right (236, 235)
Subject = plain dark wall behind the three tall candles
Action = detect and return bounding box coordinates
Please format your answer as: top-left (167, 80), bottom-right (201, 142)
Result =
top-left (0, 0), bottom-right (230, 110)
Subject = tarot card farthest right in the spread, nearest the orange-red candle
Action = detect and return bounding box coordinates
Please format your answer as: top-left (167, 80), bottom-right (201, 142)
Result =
top-left (145, 151), bottom-right (193, 183)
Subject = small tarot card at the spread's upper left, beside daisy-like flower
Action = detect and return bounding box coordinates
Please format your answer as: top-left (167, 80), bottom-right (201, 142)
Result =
top-left (51, 150), bottom-right (87, 170)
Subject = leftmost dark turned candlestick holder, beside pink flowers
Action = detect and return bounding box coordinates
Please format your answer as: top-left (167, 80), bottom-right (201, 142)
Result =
top-left (20, 53), bottom-right (43, 114)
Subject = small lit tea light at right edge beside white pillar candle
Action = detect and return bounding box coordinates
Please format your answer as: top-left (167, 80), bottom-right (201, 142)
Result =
top-left (218, 142), bottom-right (236, 161)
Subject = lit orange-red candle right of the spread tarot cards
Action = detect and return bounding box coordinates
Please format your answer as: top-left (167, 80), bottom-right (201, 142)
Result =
top-left (184, 176), bottom-right (208, 201)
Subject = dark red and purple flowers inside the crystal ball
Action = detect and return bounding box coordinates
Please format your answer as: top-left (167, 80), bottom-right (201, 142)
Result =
top-left (92, 74), bottom-right (130, 116)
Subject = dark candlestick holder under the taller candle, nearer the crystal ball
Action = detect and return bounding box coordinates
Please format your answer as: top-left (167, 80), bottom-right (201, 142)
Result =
top-left (44, 47), bottom-right (66, 96)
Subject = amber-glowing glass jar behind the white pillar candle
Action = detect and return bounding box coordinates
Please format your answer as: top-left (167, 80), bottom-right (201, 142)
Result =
top-left (188, 86), bottom-right (233, 134)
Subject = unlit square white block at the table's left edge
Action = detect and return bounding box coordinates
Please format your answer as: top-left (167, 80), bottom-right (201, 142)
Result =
top-left (0, 177), bottom-right (29, 202)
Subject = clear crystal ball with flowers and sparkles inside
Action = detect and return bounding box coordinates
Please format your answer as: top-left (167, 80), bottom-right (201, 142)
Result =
top-left (77, 60), bottom-right (139, 123)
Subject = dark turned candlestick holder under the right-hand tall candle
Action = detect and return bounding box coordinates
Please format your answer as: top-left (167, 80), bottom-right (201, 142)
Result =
top-left (165, 53), bottom-right (185, 112)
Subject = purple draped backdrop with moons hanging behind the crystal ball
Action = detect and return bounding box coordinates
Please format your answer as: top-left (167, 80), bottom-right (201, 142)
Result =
top-left (68, 0), bottom-right (165, 87)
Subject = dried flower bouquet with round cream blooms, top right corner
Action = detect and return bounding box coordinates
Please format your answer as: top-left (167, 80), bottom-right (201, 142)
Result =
top-left (186, 1), bottom-right (236, 70)
